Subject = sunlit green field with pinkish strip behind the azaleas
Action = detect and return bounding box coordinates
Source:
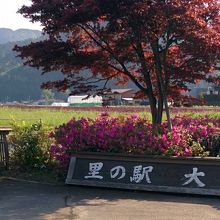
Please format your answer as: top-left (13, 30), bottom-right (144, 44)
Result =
top-left (0, 106), bottom-right (220, 127)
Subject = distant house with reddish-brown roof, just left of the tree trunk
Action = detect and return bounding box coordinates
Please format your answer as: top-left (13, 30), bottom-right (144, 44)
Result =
top-left (103, 89), bottom-right (136, 105)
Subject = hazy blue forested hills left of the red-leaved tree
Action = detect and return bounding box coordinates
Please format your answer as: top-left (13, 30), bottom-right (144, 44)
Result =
top-left (0, 29), bottom-right (64, 102)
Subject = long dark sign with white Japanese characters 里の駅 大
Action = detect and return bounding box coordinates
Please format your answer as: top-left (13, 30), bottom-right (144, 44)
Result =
top-left (66, 154), bottom-right (220, 195)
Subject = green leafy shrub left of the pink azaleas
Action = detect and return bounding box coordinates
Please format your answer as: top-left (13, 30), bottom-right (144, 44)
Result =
top-left (9, 122), bottom-right (52, 171)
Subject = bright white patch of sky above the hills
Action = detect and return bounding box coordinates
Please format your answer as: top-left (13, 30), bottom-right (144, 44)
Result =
top-left (0, 0), bottom-right (42, 30)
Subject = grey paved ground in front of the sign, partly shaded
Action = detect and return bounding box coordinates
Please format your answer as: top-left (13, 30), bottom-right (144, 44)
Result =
top-left (0, 178), bottom-right (220, 220)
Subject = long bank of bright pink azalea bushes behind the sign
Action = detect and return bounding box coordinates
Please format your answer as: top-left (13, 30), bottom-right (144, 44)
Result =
top-left (51, 113), bottom-right (220, 168)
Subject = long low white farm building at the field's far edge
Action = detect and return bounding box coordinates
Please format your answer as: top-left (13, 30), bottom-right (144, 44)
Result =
top-left (67, 95), bottom-right (102, 106)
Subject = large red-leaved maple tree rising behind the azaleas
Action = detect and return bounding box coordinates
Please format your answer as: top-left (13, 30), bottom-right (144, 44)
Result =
top-left (15, 0), bottom-right (220, 130)
